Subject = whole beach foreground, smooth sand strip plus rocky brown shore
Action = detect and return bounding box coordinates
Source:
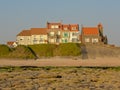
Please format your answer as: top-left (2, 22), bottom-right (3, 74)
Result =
top-left (0, 57), bottom-right (120, 90)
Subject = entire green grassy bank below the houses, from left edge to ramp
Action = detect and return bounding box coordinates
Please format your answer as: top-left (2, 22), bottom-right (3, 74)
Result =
top-left (0, 43), bottom-right (81, 59)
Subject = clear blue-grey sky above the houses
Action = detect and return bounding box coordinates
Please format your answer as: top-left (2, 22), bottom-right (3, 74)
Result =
top-left (0, 0), bottom-right (120, 46)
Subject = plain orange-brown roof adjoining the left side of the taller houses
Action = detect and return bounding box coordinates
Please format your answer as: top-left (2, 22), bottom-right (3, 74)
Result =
top-left (31, 28), bottom-right (47, 35)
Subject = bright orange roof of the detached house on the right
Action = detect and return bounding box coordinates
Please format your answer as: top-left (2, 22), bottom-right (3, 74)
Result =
top-left (82, 27), bottom-right (99, 35)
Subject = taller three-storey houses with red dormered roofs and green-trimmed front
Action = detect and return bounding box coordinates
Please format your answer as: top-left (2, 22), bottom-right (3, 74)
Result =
top-left (47, 23), bottom-right (80, 43)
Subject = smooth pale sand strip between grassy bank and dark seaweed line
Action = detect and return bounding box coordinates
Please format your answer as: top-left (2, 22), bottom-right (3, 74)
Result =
top-left (0, 58), bottom-right (120, 66)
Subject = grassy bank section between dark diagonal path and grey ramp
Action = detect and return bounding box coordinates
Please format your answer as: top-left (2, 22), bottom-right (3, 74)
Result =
top-left (29, 43), bottom-right (81, 57)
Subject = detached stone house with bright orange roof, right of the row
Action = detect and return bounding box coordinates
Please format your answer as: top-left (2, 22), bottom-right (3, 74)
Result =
top-left (80, 24), bottom-right (106, 44)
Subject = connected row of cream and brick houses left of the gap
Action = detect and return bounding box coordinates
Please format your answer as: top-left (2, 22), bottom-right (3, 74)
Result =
top-left (16, 22), bottom-right (80, 45)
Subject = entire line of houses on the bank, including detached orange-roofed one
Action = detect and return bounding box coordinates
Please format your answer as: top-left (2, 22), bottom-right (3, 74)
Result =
top-left (16, 22), bottom-right (107, 45)
